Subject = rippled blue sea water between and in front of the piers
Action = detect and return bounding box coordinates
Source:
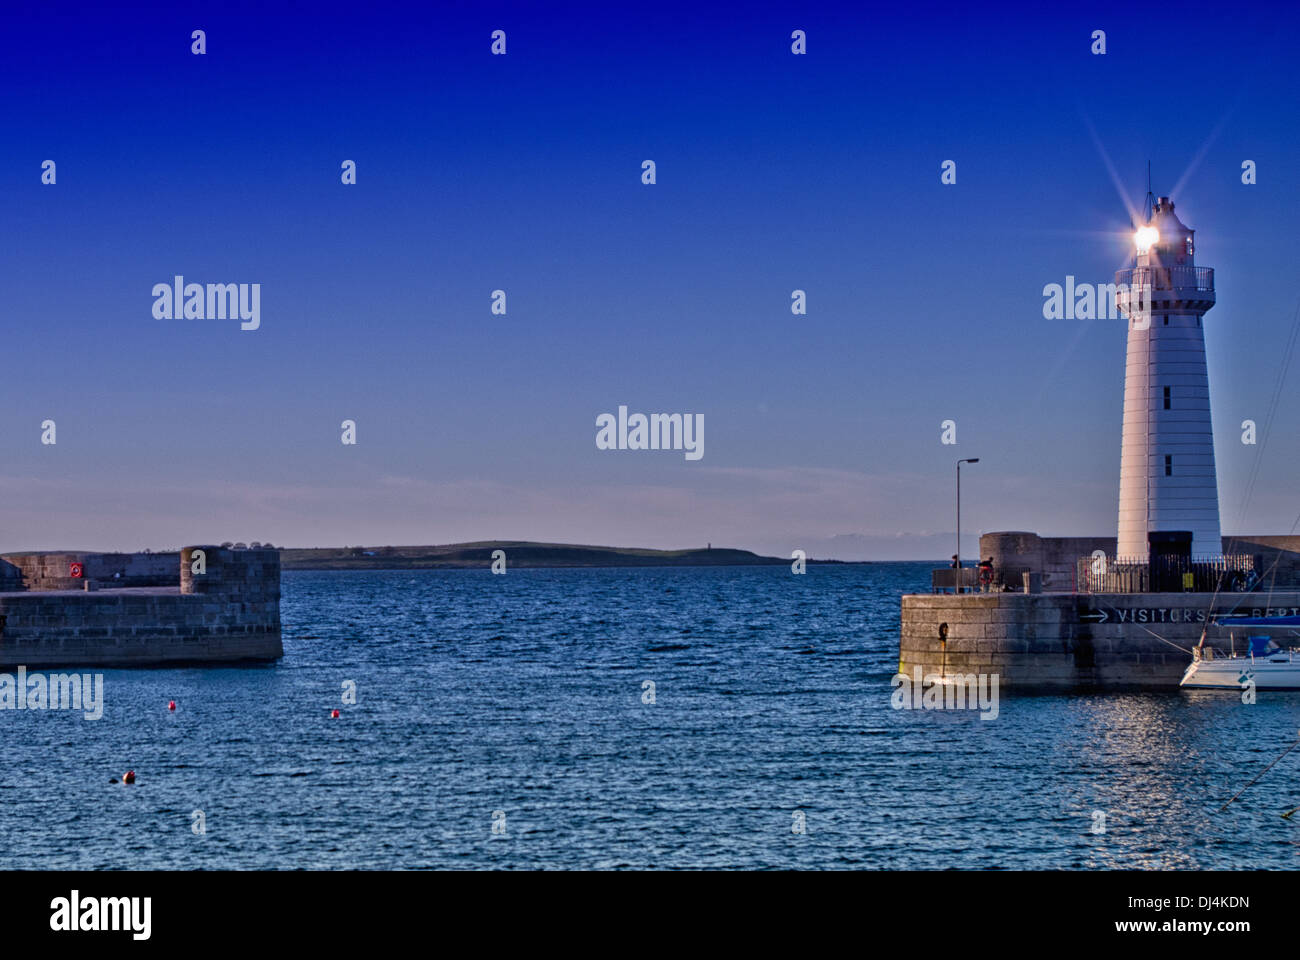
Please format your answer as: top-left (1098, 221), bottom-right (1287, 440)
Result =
top-left (0, 563), bottom-right (1300, 869)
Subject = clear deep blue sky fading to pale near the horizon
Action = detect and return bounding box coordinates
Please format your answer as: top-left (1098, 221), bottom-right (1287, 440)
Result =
top-left (0, 3), bottom-right (1300, 558)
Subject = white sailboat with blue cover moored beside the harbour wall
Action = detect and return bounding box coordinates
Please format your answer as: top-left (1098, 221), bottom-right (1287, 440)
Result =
top-left (1178, 617), bottom-right (1300, 689)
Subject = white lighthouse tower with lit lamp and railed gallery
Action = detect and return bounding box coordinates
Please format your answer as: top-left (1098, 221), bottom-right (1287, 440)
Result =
top-left (1115, 196), bottom-right (1223, 561)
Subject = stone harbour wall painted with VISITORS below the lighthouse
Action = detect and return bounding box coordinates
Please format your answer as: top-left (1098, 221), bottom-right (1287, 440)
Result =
top-left (898, 587), bottom-right (1300, 691)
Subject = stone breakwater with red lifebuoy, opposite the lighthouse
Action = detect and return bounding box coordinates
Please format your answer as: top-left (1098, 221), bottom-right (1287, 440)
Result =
top-left (0, 546), bottom-right (283, 667)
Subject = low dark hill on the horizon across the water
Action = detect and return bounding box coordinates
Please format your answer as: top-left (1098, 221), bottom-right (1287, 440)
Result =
top-left (280, 540), bottom-right (790, 570)
